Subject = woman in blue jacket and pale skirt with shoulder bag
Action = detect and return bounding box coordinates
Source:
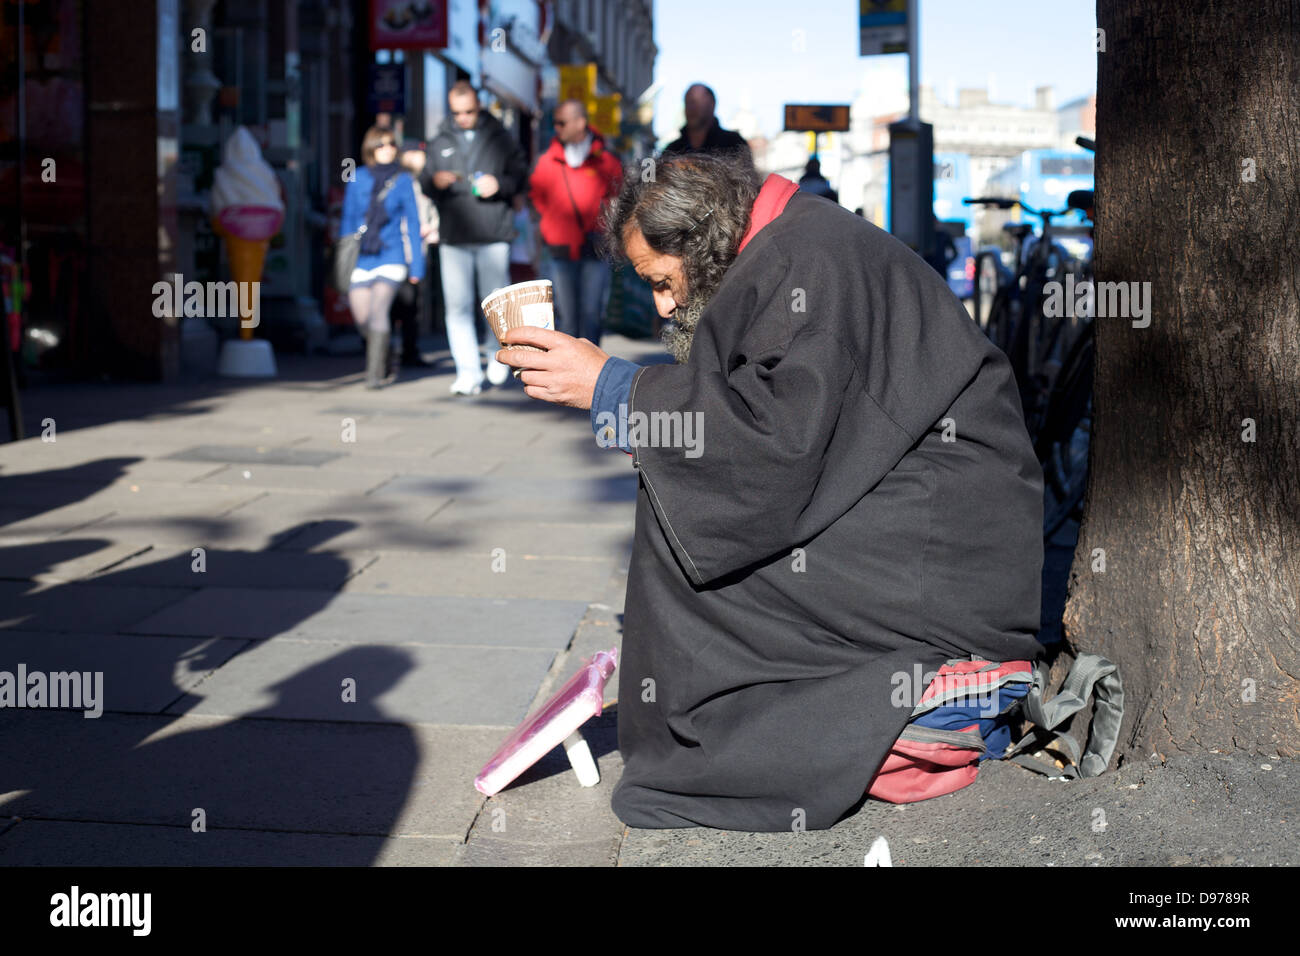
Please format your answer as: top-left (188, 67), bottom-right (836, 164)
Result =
top-left (339, 126), bottom-right (424, 389)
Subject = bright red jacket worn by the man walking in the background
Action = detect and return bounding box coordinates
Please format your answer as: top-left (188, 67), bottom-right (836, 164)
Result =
top-left (528, 129), bottom-right (623, 259)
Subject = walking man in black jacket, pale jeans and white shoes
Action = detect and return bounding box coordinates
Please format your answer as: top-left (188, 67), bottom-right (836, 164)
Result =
top-left (425, 81), bottom-right (528, 395)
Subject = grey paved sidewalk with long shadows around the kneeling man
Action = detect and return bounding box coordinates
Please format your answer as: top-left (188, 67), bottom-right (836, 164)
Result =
top-left (0, 337), bottom-right (1300, 866)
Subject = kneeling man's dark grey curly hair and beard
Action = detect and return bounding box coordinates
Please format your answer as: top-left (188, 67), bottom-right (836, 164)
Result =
top-left (601, 150), bottom-right (762, 362)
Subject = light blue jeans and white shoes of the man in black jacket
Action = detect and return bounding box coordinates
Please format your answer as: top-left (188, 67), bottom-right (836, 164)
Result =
top-left (438, 242), bottom-right (510, 385)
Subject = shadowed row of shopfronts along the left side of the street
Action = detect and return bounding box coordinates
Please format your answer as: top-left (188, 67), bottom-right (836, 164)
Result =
top-left (0, 0), bottom-right (655, 381)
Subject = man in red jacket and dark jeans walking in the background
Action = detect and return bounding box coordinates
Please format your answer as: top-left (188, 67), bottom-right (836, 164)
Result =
top-left (529, 100), bottom-right (623, 345)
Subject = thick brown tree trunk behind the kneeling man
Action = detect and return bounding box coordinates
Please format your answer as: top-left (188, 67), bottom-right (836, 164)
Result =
top-left (1065, 0), bottom-right (1300, 758)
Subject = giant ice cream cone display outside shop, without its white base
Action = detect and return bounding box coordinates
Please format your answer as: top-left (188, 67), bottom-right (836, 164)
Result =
top-left (212, 126), bottom-right (285, 339)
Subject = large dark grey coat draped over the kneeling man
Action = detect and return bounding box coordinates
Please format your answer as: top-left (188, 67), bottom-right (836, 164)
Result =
top-left (612, 194), bottom-right (1043, 831)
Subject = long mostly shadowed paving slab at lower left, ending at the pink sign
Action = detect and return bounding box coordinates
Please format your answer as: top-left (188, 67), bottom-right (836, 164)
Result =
top-left (0, 711), bottom-right (506, 842)
